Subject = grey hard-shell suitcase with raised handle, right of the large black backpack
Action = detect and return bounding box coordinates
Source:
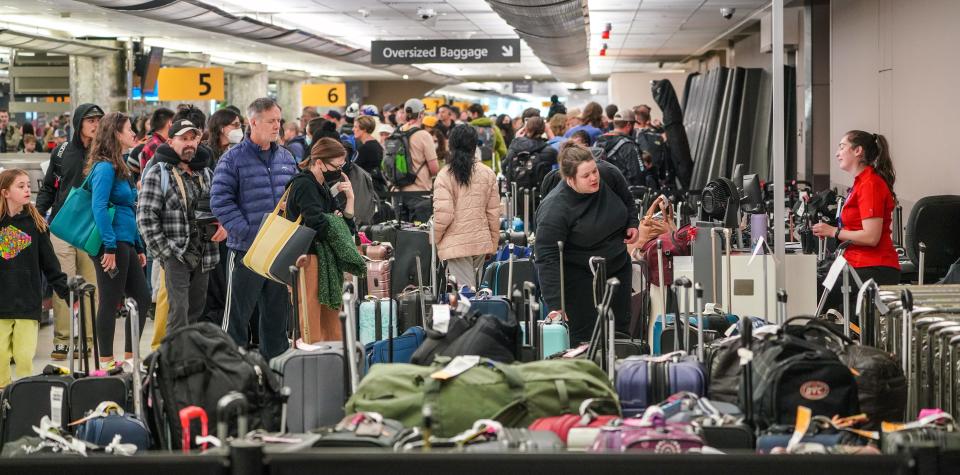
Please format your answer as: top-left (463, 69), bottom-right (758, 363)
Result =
top-left (270, 266), bottom-right (349, 433)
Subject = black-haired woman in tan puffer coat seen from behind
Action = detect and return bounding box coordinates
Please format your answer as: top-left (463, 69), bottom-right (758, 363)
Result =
top-left (433, 125), bottom-right (500, 288)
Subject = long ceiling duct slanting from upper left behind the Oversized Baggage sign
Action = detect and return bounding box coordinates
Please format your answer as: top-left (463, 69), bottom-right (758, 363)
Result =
top-left (79, 0), bottom-right (460, 84)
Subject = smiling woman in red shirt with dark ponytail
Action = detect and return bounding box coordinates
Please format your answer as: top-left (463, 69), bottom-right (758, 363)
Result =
top-left (813, 130), bottom-right (900, 306)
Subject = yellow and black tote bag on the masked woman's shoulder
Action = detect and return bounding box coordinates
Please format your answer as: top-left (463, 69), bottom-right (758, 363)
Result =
top-left (243, 188), bottom-right (317, 286)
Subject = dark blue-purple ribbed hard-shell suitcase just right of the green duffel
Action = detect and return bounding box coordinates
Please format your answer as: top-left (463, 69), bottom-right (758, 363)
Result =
top-left (616, 351), bottom-right (707, 417)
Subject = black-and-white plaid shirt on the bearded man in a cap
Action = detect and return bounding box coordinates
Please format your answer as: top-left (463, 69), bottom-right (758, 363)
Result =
top-left (137, 163), bottom-right (220, 272)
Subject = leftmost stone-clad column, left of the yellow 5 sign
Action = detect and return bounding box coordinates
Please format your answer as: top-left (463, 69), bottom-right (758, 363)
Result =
top-left (70, 40), bottom-right (127, 112)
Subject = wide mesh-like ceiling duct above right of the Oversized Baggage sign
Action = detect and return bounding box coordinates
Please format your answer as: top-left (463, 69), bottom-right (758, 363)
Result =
top-left (487, 0), bottom-right (590, 82)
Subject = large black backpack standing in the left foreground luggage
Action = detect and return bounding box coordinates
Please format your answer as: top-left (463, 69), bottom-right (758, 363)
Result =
top-left (144, 322), bottom-right (281, 450)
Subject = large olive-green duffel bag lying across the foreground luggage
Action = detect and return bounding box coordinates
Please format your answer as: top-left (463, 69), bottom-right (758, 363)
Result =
top-left (346, 357), bottom-right (620, 437)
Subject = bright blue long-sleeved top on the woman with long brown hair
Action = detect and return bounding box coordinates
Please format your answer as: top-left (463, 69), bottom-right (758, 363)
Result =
top-left (90, 162), bottom-right (143, 253)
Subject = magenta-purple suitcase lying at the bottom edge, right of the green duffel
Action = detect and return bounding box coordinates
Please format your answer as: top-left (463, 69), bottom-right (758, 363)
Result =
top-left (590, 408), bottom-right (704, 454)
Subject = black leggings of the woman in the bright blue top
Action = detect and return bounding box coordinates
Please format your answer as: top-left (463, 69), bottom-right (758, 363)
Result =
top-left (93, 242), bottom-right (150, 357)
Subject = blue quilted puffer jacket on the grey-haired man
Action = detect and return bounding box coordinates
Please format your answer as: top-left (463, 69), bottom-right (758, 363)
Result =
top-left (210, 136), bottom-right (298, 251)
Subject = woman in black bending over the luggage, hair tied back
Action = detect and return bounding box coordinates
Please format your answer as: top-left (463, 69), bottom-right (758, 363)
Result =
top-left (535, 142), bottom-right (639, 344)
